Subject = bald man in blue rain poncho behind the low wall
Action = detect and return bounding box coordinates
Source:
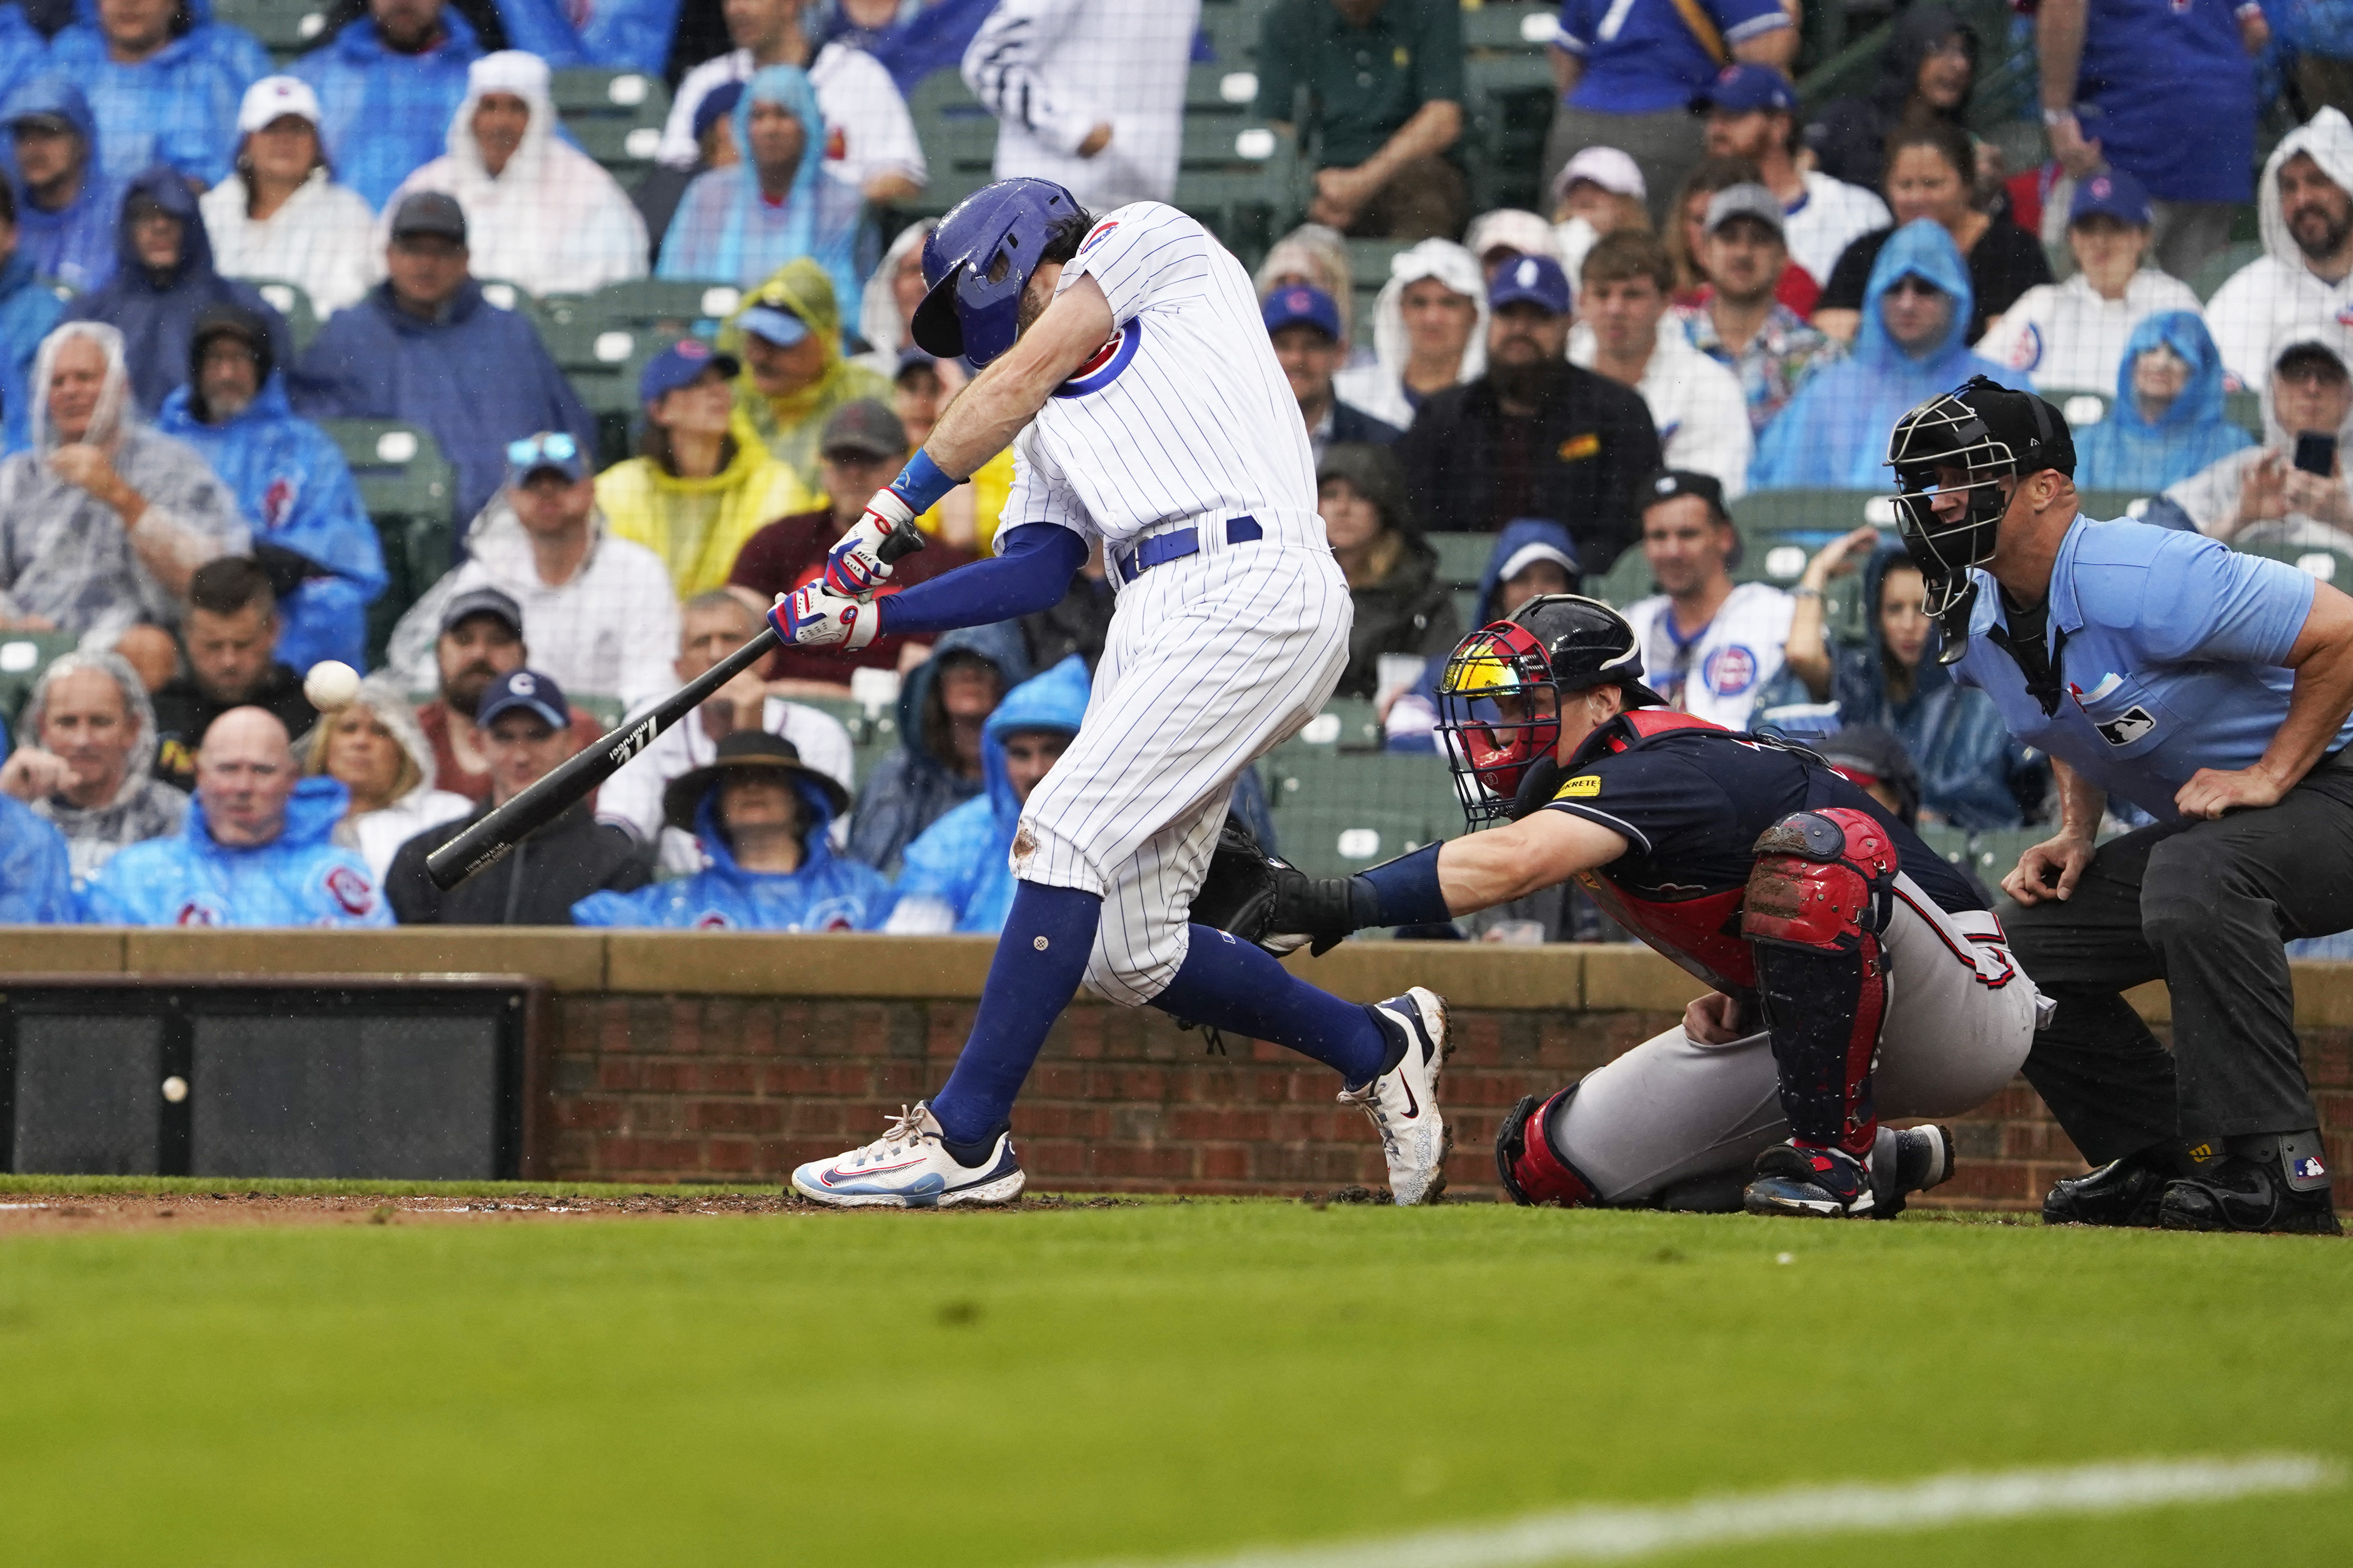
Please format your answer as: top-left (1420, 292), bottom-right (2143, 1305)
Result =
top-left (85, 708), bottom-right (393, 926)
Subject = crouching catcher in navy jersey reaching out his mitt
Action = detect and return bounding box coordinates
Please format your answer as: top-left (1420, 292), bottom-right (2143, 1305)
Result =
top-left (1259, 595), bottom-right (2040, 1218)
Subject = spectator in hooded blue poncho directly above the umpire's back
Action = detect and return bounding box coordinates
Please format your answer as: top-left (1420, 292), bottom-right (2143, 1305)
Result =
top-left (2075, 310), bottom-right (2254, 494)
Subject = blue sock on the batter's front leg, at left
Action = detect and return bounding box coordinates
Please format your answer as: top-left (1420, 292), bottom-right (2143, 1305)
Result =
top-left (932, 882), bottom-right (1104, 1166)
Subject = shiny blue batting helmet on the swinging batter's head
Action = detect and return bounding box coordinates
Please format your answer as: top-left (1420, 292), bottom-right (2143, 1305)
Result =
top-left (913, 179), bottom-right (1087, 365)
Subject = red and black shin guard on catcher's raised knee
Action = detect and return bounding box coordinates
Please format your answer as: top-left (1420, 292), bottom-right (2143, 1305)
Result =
top-left (1741, 806), bottom-right (1896, 1159)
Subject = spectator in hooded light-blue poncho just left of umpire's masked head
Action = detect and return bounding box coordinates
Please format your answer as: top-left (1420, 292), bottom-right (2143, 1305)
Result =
top-left (1748, 219), bottom-right (2028, 489)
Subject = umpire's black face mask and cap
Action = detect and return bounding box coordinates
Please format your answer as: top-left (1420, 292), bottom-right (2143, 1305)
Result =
top-left (1887, 376), bottom-right (2075, 630)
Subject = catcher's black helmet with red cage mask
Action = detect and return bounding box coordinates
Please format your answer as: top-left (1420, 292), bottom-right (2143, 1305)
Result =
top-left (1438, 592), bottom-right (1661, 830)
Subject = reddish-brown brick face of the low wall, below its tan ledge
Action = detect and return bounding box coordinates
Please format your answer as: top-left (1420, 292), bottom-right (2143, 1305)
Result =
top-left (548, 997), bottom-right (2353, 1209)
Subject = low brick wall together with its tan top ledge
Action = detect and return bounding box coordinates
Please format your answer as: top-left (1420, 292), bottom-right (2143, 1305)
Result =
top-left (14, 926), bottom-right (2353, 1209)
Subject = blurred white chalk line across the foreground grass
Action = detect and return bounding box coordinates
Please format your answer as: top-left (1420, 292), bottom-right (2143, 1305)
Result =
top-left (1078, 1453), bottom-right (2344, 1568)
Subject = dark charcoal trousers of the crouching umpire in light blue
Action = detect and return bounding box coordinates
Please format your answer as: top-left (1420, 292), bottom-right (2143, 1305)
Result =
top-left (2000, 757), bottom-right (2353, 1166)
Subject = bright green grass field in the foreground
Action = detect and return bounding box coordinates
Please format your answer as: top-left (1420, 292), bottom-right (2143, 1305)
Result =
top-left (0, 1180), bottom-right (2353, 1568)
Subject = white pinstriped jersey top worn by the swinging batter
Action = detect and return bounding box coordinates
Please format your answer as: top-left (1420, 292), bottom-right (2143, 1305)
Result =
top-left (997, 202), bottom-right (1320, 548)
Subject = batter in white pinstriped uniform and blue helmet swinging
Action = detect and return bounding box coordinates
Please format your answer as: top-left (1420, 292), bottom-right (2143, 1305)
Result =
top-left (769, 179), bottom-right (1449, 1206)
